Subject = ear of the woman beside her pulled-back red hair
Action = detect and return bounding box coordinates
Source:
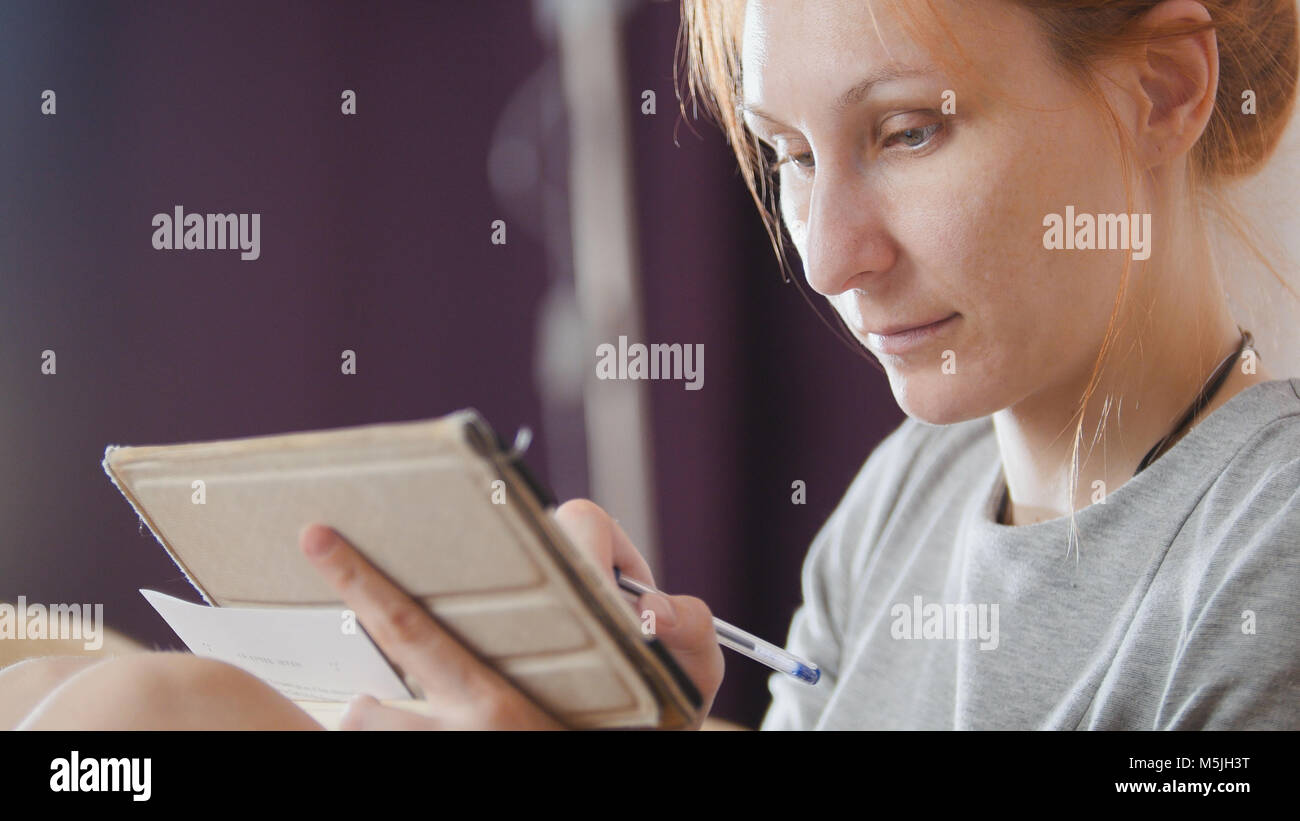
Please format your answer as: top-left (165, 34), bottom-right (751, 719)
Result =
top-left (1130, 0), bottom-right (1218, 169)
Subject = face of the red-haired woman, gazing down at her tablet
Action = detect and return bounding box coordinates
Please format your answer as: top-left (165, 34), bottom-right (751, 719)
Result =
top-left (741, 0), bottom-right (1158, 423)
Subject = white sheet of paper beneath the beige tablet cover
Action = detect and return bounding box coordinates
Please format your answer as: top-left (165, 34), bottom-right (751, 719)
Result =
top-left (140, 590), bottom-right (412, 701)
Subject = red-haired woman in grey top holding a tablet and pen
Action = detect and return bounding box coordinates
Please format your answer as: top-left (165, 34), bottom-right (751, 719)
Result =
top-left (0, 0), bottom-right (1300, 729)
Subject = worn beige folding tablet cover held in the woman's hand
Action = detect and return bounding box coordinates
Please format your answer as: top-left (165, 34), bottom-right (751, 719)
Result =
top-left (104, 411), bottom-right (696, 727)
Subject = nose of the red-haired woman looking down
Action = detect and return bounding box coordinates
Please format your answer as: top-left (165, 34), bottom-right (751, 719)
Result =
top-left (803, 166), bottom-right (897, 296)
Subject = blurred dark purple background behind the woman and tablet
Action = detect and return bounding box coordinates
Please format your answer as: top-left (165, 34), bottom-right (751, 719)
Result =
top-left (0, 0), bottom-right (1300, 726)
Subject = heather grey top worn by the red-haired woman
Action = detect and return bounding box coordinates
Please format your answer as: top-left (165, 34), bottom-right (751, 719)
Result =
top-left (763, 378), bottom-right (1300, 729)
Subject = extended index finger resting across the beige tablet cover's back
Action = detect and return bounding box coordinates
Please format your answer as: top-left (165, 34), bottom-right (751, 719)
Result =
top-left (299, 525), bottom-right (498, 699)
